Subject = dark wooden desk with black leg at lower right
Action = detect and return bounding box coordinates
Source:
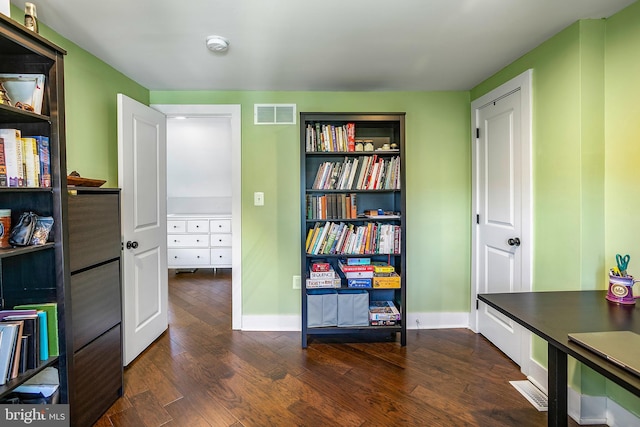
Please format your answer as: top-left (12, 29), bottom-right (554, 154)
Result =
top-left (478, 291), bottom-right (640, 426)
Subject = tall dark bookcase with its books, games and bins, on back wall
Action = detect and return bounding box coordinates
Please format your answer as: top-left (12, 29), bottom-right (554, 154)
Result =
top-left (300, 113), bottom-right (407, 347)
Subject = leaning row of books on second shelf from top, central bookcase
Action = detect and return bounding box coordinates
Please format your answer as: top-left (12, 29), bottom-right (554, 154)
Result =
top-left (312, 154), bottom-right (400, 190)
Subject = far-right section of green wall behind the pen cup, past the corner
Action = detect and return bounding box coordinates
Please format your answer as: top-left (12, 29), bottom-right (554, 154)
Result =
top-left (604, 2), bottom-right (640, 416)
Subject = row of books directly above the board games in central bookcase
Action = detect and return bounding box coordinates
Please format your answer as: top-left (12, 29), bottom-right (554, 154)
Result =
top-left (306, 221), bottom-right (402, 255)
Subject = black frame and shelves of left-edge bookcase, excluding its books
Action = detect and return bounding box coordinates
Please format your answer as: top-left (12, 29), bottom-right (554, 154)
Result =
top-left (0, 14), bottom-right (73, 403)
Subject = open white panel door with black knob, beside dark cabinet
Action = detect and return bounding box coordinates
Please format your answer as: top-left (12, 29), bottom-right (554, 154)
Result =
top-left (118, 94), bottom-right (168, 366)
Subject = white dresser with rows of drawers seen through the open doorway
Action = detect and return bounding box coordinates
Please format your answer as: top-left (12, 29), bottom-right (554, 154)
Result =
top-left (167, 214), bottom-right (231, 269)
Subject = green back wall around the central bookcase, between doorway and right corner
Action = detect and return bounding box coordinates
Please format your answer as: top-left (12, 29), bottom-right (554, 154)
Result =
top-left (151, 91), bottom-right (471, 315)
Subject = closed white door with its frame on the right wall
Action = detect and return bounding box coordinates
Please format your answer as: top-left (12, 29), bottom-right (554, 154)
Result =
top-left (472, 70), bottom-right (531, 371)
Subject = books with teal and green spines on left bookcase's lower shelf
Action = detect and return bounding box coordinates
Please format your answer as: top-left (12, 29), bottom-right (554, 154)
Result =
top-left (0, 303), bottom-right (59, 385)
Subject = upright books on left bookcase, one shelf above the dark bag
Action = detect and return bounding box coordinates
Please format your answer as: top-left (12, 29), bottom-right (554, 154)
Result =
top-left (0, 129), bottom-right (51, 188)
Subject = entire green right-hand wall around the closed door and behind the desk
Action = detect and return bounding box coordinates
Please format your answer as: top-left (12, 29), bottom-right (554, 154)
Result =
top-left (471, 3), bottom-right (640, 416)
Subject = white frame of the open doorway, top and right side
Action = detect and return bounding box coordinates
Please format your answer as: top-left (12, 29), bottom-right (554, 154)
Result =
top-left (151, 104), bottom-right (242, 329)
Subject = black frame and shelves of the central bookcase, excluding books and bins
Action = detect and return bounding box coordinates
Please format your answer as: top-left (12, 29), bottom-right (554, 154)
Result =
top-left (300, 113), bottom-right (407, 348)
